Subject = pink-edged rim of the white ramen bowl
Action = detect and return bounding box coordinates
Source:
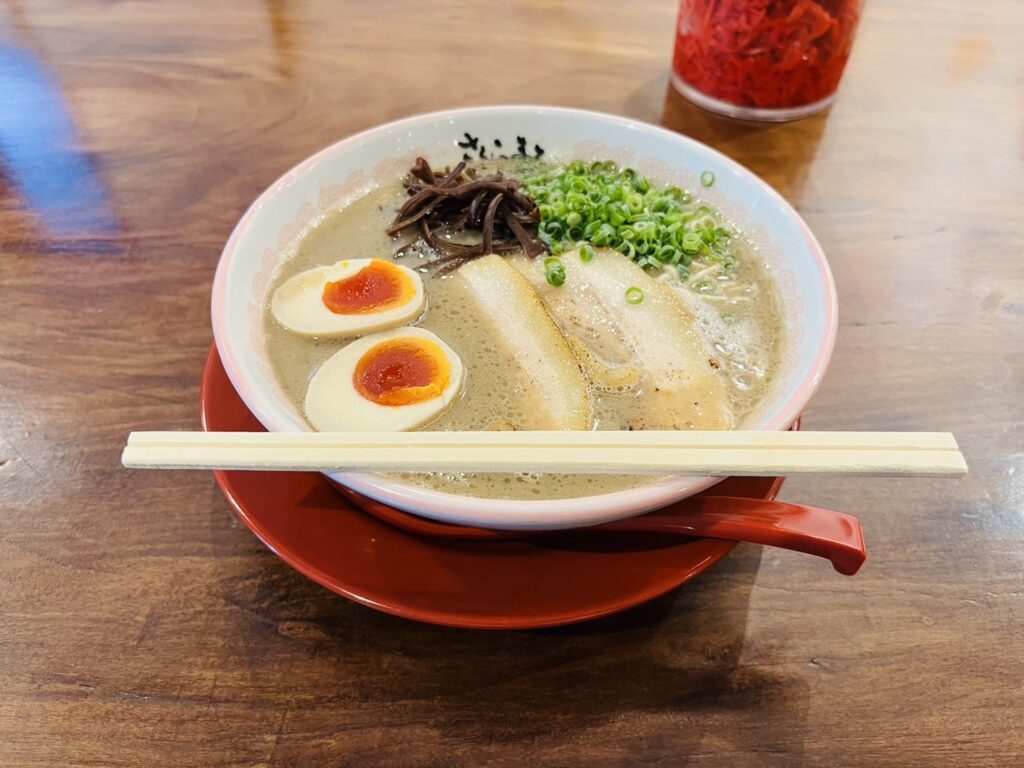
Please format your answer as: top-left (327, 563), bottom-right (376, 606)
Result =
top-left (211, 103), bottom-right (839, 528)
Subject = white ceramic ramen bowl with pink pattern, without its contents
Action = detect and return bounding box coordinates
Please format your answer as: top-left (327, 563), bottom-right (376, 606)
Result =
top-left (212, 106), bottom-right (837, 529)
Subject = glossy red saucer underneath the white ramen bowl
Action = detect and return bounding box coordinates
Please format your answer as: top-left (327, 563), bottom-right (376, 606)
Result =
top-left (201, 347), bottom-right (782, 629)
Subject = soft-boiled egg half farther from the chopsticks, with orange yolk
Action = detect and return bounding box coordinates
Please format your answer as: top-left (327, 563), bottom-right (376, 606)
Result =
top-left (270, 259), bottom-right (426, 339)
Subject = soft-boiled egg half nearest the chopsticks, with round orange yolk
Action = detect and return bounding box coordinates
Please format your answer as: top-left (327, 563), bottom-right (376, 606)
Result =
top-left (305, 328), bottom-right (464, 432)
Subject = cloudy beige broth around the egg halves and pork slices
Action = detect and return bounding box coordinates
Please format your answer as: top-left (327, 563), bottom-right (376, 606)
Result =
top-left (265, 159), bottom-right (782, 499)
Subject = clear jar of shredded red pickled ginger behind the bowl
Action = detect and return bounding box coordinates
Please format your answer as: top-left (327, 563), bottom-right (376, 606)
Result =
top-left (672, 0), bottom-right (861, 121)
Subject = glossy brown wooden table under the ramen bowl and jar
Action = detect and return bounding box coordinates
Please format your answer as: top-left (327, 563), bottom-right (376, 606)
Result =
top-left (0, 0), bottom-right (1024, 768)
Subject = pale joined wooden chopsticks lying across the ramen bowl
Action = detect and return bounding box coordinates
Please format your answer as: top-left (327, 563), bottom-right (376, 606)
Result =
top-left (121, 431), bottom-right (967, 476)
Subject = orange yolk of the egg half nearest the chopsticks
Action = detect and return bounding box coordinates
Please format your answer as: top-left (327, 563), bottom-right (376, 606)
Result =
top-left (352, 338), bottom-right (452, 406)
